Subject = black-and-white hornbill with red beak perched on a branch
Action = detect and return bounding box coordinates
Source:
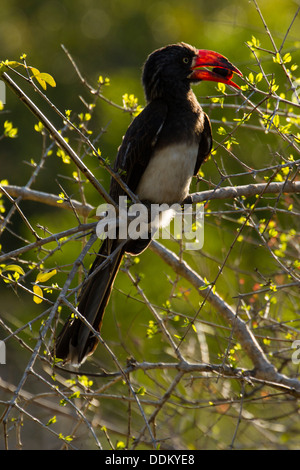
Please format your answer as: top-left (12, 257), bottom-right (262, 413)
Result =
top-left (53, 43), bottom-right (242, 365)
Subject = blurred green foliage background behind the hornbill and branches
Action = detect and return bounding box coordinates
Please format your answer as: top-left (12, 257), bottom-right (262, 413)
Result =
top-left (0, 0), bottom-right (300, 449)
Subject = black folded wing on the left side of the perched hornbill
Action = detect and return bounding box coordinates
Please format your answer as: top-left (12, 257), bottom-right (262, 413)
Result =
top-left (110, 100), bottom-right (168, 202)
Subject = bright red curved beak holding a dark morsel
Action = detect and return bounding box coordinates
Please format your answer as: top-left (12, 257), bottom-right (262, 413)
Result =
top-left (189, 49), bottom-right (243, 90)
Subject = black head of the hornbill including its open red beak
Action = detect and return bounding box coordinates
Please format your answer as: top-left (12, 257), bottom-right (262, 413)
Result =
top-left (142, 43), bottom-right (242, 101)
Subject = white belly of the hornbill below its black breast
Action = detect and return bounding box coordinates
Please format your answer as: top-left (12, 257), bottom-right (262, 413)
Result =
top-left (136, 144), bottom-right (198, 204)
